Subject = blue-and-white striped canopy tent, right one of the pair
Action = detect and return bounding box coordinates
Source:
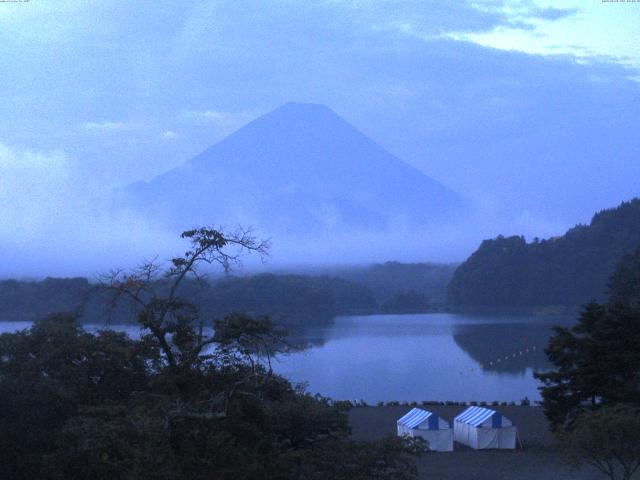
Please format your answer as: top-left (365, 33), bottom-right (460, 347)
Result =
top-left (453, 407), bottom-right (518, 450)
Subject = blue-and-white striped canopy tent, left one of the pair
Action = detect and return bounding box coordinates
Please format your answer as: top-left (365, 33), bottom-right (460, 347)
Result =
top-left (397, 408), bottom-right (453, 452)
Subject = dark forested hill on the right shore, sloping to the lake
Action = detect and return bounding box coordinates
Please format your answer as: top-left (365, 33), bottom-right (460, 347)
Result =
top-left (447, 198), bottom-right (640, 308)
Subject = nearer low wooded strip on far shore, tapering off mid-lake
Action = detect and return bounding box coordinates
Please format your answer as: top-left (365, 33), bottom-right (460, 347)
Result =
top-left (0, 274), bottom-right (378, 326)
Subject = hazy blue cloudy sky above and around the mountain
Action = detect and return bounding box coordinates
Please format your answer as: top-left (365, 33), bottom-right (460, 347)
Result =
top-left (0, 0), bottom-right (640, 273)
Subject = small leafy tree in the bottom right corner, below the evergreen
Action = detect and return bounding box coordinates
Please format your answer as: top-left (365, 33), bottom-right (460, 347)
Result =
top-left (563, 405), bottom-right (640, 480)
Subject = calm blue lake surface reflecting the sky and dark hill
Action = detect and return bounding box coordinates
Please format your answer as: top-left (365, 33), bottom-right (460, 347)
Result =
top-left (0, 313), bottom-right (573, 403)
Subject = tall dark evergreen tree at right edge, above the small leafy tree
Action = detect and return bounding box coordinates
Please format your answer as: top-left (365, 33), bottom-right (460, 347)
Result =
top-left (536, 249), bottom-right (640, 429)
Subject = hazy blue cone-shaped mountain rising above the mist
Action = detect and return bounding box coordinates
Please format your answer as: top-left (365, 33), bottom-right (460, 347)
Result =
top-left (126, 103), bottom-right (467, 242)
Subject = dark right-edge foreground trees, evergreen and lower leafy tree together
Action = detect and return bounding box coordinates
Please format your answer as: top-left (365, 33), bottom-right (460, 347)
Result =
top-left (536, 248), bottom-right (640, 480)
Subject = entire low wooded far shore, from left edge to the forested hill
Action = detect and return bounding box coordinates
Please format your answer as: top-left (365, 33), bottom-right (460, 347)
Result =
top-left (0, 262), bottom-right (453, 328)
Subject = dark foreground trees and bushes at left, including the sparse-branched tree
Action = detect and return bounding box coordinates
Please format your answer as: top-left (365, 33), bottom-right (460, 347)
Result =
top-left (0, 229), bottom-right (422, 480)
